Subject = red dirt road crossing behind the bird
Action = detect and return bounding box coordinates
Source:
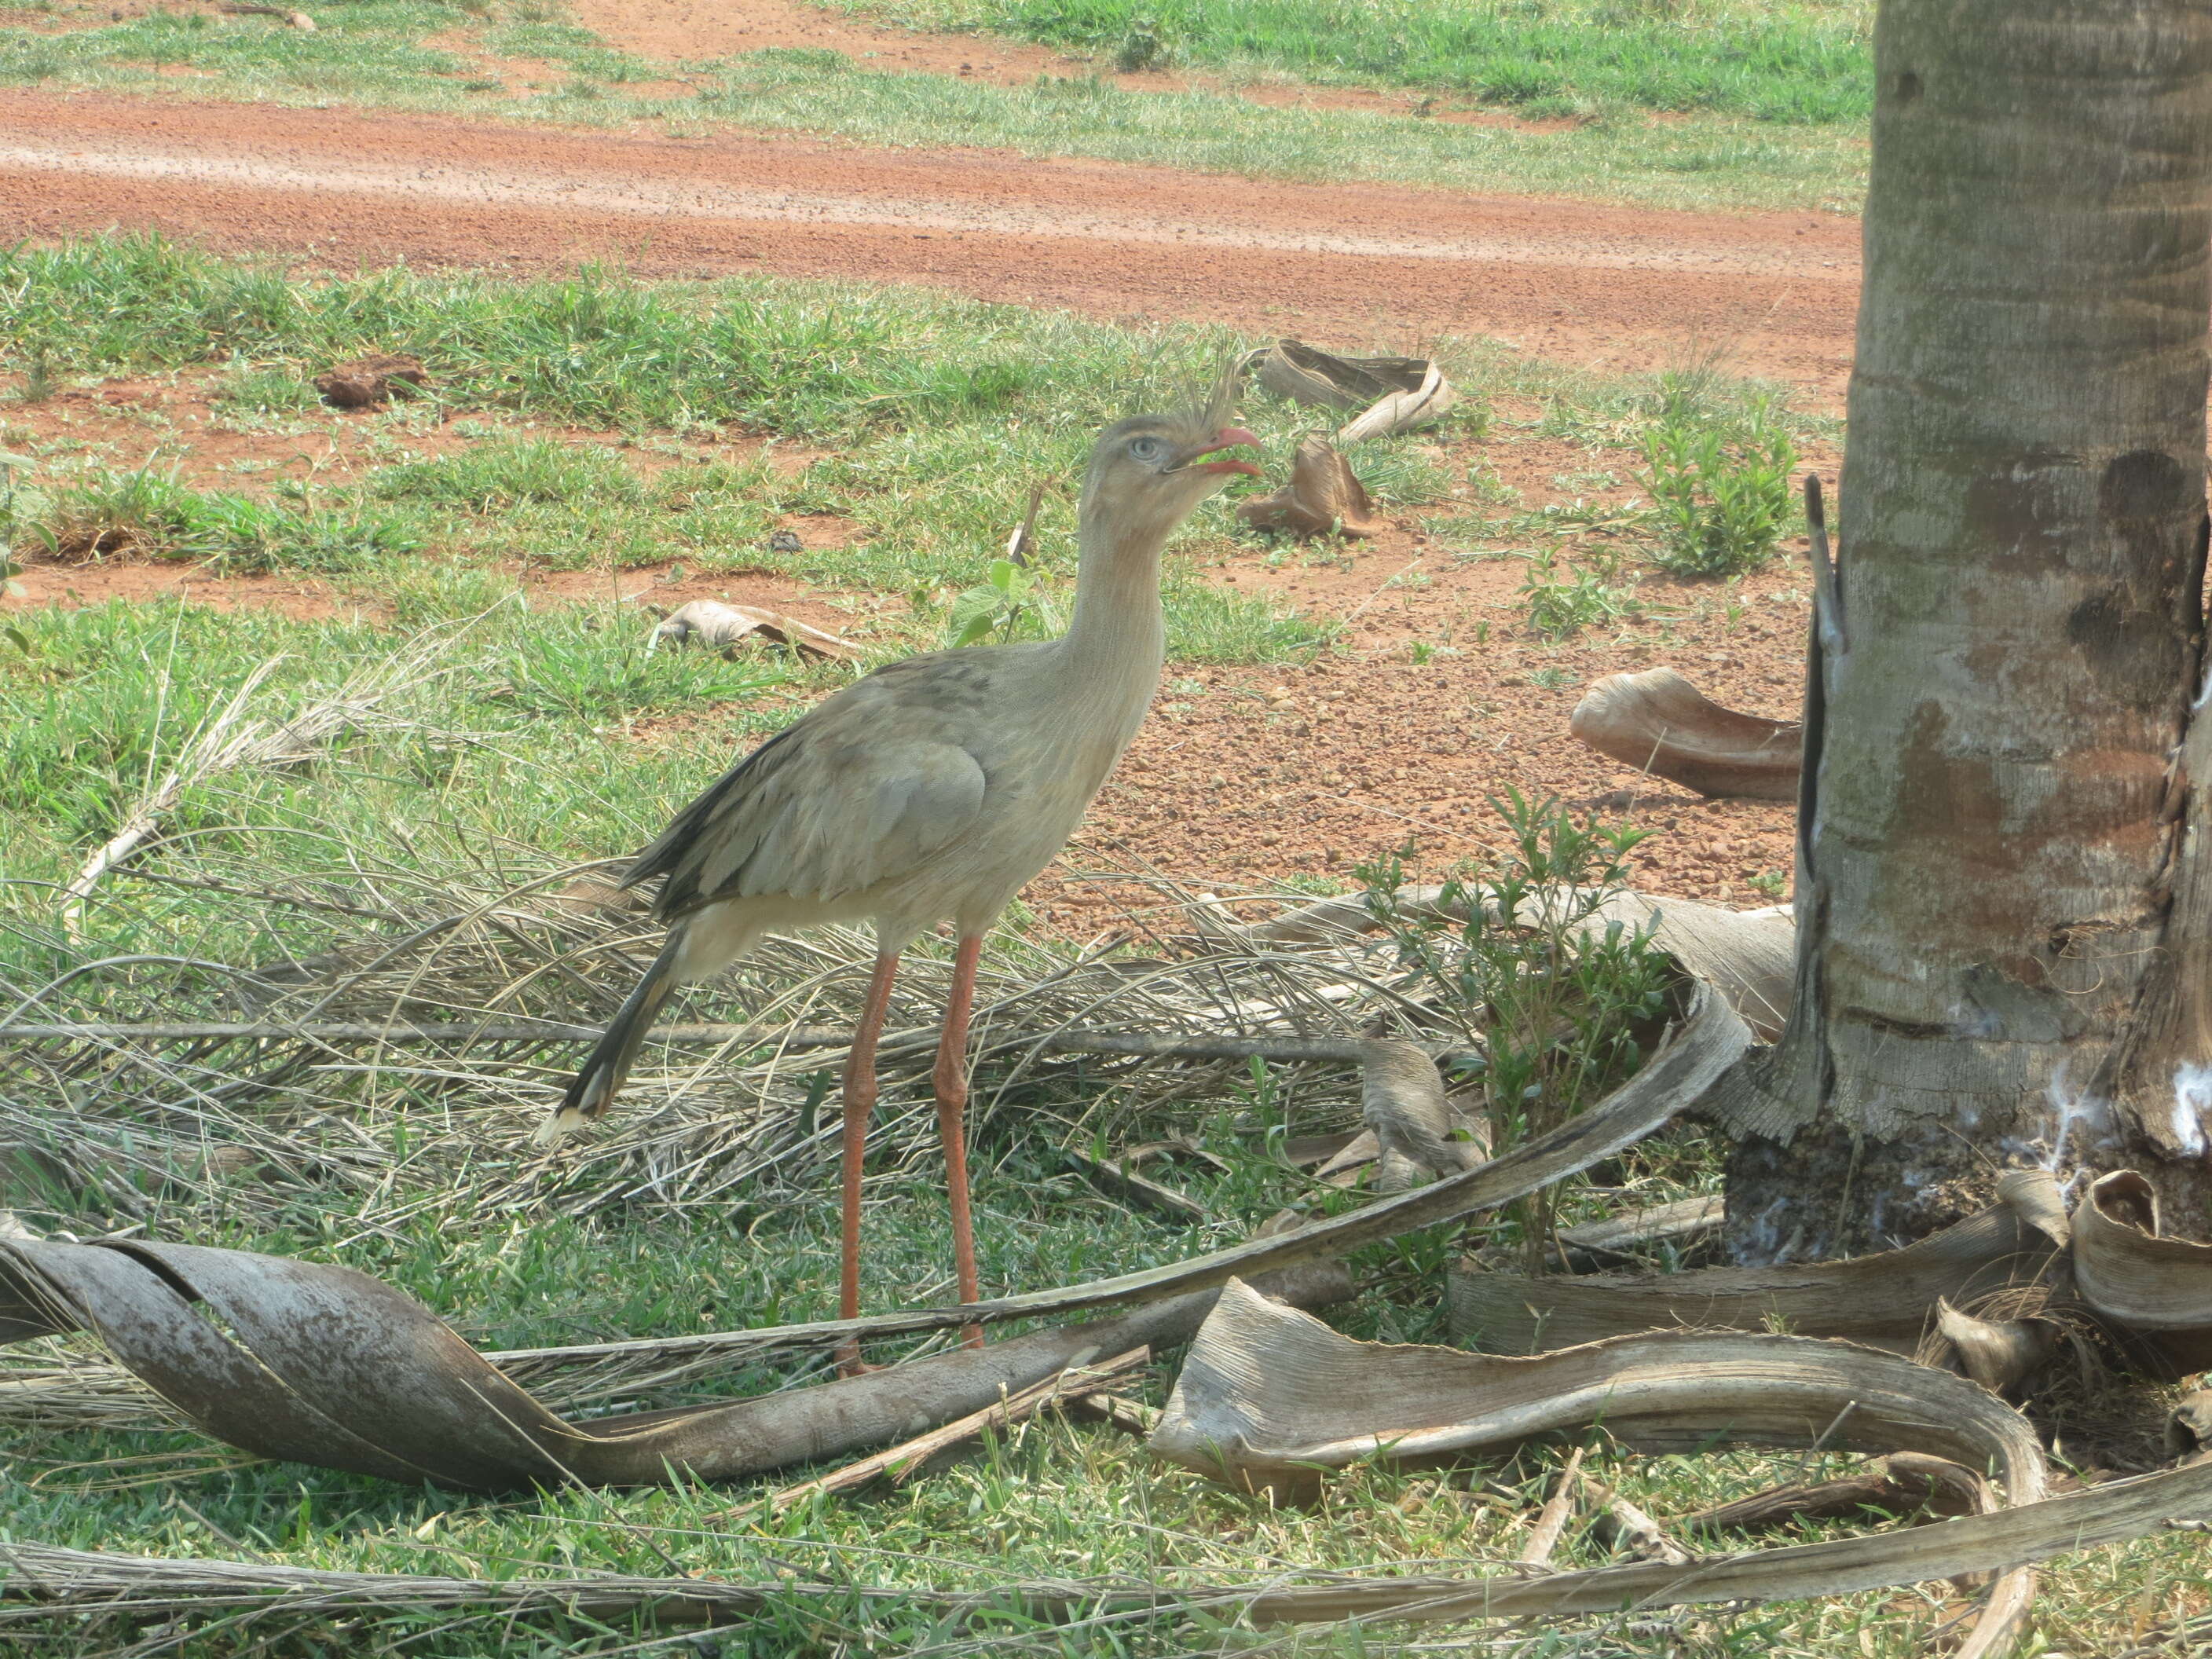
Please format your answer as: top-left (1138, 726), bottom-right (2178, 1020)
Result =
top-left (0, 90), bottom-right (1858, 405)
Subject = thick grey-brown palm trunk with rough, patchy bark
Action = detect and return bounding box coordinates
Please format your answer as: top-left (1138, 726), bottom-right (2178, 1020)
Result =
top-left (1721, 0), bottom-right (2212, 1261)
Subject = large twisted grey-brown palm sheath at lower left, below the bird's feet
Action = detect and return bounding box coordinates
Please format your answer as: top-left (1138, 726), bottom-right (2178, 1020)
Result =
top-left (0, 1239), bottom-right (1327, 1491)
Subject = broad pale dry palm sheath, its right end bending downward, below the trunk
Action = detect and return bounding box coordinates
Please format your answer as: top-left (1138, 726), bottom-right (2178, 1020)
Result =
top-left (1150, 1283), bottom-right (2046, 1654)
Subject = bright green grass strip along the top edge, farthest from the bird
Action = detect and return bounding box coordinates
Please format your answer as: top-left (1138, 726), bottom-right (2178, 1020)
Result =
top-left (854, 0), bottom-right (1873, 126)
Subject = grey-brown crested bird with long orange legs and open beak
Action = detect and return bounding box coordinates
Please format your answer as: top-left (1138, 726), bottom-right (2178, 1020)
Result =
top-left (540, 374), bottom-right (1261, 1374)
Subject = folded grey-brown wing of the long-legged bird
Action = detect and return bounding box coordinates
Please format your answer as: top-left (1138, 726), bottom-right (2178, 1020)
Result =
top-left (624, 675), bottom-right (984, 918)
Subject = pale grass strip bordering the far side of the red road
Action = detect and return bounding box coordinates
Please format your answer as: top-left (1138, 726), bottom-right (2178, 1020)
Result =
top-left (0, 0), bottom-right (1867, 212)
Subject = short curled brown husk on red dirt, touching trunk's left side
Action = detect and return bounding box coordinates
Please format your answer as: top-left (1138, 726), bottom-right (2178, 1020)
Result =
top-left (1566, 668), bottom-right (1805, 800)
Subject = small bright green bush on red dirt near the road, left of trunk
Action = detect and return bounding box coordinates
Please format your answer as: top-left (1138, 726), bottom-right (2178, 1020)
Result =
top-left (1637, 398), bottom-right (1796, 575)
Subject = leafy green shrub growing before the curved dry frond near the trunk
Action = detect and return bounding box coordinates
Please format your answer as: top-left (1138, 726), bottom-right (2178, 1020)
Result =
top-left (1358, 789), bottom-right (1670, 1269)
